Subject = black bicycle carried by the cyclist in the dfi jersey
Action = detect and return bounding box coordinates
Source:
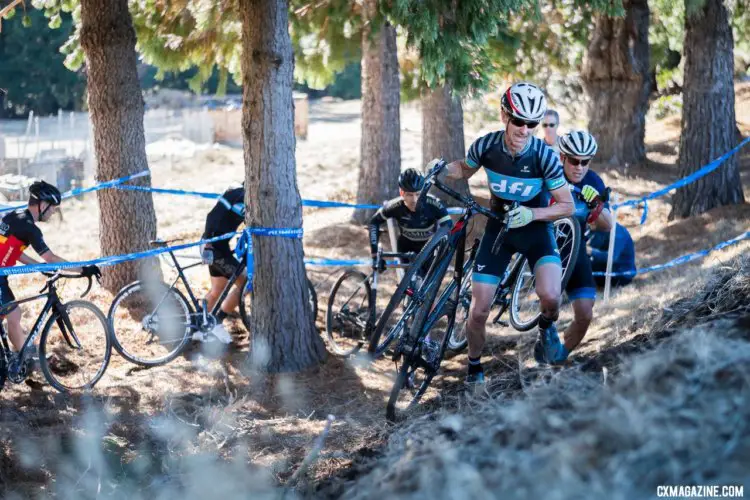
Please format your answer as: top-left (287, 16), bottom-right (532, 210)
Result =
top-left (382, 161), bottom-right (580, 421)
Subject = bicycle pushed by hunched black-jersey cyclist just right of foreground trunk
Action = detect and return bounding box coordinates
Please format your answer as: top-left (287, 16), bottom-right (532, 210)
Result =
top-left (326, 248), bottom-right (416, 356)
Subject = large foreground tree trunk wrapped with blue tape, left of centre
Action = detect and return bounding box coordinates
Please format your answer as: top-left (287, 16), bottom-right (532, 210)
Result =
top-left (240, 0), bottom-right (325, 372)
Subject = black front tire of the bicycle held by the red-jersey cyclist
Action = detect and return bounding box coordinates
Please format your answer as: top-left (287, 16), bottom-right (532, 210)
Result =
top-left (39, 300), bottom-right (112, 393)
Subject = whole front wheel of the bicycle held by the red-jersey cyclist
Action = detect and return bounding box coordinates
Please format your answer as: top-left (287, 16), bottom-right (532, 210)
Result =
top-left (39, 300), bottom-right (112, 392)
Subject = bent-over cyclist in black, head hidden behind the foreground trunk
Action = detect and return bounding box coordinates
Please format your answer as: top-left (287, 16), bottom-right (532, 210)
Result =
top-left (200, 182), bottom-right (247, 344)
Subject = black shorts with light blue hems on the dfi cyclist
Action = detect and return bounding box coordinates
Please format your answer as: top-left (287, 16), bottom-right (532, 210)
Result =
top-left (472, 219), bottom-right (562, 286)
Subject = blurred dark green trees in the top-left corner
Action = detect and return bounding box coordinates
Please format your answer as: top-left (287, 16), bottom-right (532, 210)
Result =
top-left (0, 9), bottom-right (85, 117)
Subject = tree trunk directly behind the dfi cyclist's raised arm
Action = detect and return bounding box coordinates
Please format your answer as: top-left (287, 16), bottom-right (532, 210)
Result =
top-left (422, 85), bottom-right (469, 205)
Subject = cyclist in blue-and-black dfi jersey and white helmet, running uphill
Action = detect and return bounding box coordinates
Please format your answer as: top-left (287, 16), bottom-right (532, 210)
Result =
top-left (446, 82), bottom-right (575, 384)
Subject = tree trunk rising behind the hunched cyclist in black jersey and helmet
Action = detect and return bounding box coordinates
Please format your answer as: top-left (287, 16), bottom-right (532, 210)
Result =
top-left (353, 0), bottom-right (401, 224)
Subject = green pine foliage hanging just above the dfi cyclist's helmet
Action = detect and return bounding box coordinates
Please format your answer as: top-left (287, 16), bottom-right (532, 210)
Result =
top-left (385, 0), bottom-right (623, 95)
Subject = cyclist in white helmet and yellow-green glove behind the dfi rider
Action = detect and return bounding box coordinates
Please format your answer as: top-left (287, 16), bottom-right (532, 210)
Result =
top-left (551, 130), bottom-right (612, 363)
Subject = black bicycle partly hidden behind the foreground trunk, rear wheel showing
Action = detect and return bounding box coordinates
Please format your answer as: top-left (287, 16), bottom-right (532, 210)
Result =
top-left (107, 236), bottom-right (318, 366)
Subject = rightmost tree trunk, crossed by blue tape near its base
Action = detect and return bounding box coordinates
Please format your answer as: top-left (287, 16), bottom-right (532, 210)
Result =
top-left (669, 0), bottom-right (745, 220)
